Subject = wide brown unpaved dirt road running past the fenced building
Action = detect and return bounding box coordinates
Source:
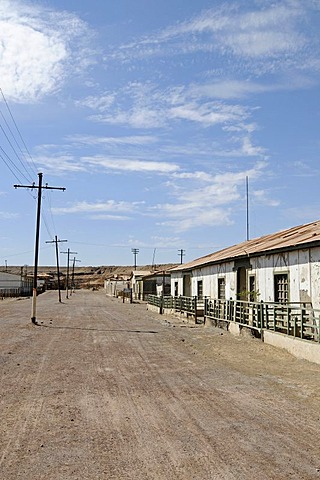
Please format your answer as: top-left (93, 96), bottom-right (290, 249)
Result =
top-left (0, 291), bottom-right (320, 480)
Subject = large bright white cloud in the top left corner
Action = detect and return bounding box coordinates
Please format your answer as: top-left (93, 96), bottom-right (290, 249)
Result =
top-left (0, 0), bottom-right (88, 103)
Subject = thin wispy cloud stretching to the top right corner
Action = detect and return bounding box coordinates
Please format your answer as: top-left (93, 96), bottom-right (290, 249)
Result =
top-left (106, 0), bottom-right (319, 75)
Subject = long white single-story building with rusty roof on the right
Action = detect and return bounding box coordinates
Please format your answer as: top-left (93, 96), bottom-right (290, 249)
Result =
top-left (170, 220), bottom-right (320, 309)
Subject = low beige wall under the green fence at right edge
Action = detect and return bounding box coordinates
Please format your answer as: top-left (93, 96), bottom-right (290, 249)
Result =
top-left (263, 330), bottom-right (320, 365)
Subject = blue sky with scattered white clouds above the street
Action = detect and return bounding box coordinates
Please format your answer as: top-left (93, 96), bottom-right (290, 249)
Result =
top-left (0, 0), bottom-right (320, 265)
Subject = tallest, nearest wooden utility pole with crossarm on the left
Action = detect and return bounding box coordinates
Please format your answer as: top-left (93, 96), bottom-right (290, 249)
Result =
top-left (14, 173), bottom-right (65, 325)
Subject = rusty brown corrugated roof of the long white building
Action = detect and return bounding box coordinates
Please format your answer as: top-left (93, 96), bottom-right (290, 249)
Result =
top-left (171, 220), bottom-right (320, 271)
